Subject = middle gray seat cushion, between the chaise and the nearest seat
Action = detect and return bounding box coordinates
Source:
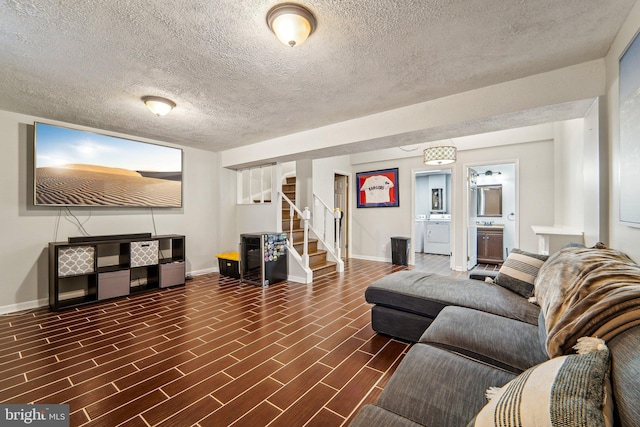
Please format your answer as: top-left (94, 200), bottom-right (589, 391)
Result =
top-left (420, 307), bottom-right (549, 374)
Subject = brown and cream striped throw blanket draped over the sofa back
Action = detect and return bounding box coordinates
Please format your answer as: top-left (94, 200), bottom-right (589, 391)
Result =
top-left (535, 247), bottom-right (640, 357)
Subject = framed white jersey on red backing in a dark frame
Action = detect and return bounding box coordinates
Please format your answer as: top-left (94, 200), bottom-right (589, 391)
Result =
top-left (356, 168), bottom-right (400, 208)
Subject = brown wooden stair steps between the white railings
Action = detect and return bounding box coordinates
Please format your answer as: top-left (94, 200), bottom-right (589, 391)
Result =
top-left (282, 177), bottom-right (336, 279)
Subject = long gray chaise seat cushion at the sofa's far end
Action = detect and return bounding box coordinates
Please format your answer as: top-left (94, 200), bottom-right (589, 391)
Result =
top-left (365, 271), bottom-right (540, 325)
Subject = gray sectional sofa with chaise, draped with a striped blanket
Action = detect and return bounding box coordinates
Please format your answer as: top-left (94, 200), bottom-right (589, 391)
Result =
top-left (351, 247), bottom-right (640, 427)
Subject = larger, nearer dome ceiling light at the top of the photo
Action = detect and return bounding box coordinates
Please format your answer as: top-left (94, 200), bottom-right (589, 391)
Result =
top-left (267, 3), bottom-right (316, 47)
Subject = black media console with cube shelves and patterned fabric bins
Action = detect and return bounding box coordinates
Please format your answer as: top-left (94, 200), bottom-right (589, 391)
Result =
top-left (49, 233), bottom-right (185, 311)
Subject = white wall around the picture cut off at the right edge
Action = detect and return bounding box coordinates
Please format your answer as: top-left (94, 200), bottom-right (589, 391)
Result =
top-left (605, 2), bottom-right (640, 262)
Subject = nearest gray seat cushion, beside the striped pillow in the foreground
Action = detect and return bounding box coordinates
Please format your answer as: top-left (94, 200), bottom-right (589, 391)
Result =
top-left (376, 343), bottom-right (515, 426)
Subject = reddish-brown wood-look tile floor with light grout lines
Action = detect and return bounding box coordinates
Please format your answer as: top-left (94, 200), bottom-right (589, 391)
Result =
top-left (0, 256), bottom-right (464, 427)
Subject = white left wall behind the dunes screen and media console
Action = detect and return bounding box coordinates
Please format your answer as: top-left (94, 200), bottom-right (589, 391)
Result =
top-left (0, 111), bottom-right (218, 312)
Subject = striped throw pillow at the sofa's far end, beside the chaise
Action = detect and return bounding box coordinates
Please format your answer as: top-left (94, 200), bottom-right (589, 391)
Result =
top-left (494, 249), bottom-right (549, 298)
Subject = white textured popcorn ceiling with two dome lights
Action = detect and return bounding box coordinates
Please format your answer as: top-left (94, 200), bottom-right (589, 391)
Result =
top-left (0, 0), bottom-right (635, 151)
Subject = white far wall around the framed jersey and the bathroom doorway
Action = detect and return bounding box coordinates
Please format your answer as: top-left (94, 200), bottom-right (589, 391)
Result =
top-left (351, 135), bottom-right (554, 270)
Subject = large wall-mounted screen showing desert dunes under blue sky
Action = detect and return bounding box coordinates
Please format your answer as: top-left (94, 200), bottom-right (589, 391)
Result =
top-left (34, 123), bottom-right (182, 207)
